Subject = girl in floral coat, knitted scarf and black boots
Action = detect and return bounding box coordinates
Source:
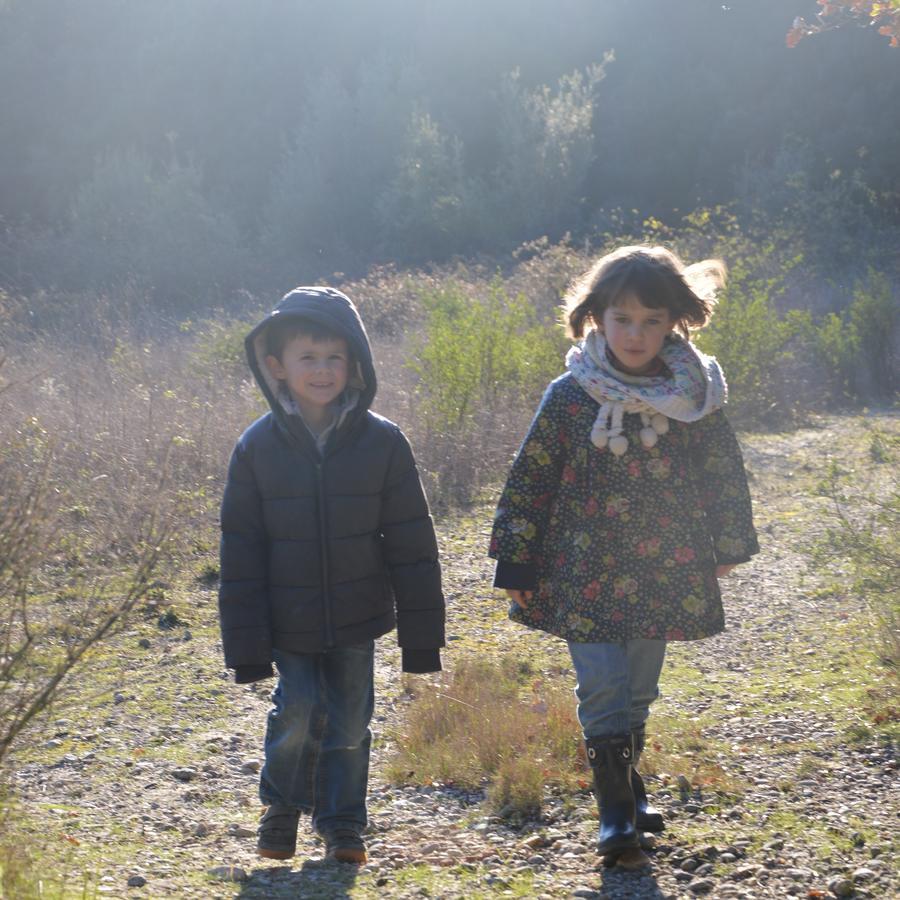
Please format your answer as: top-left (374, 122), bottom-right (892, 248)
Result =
top-left (490, 247), bottom-right (759, 867)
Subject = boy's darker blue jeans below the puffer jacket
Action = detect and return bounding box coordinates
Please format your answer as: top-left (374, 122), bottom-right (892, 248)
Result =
top-left (259, 641), bottom-right (375, 834)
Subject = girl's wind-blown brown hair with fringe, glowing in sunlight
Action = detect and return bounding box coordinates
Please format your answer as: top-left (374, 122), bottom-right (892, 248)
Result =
top-left (563, 246), bottom-right (726, 338)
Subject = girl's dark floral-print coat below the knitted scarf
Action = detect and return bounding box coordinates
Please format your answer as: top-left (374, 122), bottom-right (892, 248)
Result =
top-left (490, 374), bottom-right (759, 642)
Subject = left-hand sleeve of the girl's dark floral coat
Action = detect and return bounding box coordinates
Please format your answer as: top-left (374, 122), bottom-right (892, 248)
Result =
top-left (488, 384), bottom-right (564, 590)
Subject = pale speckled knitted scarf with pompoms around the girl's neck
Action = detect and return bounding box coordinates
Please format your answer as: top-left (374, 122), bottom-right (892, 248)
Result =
top-left (566, 330), bottom-right (728, 456)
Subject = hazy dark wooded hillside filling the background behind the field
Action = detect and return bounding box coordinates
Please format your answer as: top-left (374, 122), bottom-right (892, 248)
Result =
top-left (0, 0), bottom-right (900, 308)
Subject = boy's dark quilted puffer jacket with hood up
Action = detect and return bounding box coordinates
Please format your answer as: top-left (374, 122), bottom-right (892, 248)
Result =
top-left (219, 287), bottom-right (444, 681)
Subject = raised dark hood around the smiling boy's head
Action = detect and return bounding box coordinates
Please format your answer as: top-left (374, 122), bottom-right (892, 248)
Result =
top-left (244, 286), bottom-right (378, 428)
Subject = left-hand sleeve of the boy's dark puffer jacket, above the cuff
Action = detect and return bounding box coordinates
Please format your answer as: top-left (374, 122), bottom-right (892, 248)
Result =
top-left (219, 443), bottom-right (272, 668)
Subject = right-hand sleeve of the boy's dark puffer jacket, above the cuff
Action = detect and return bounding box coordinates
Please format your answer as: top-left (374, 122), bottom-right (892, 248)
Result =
top-left (380, 429), bottom-right (444, 650)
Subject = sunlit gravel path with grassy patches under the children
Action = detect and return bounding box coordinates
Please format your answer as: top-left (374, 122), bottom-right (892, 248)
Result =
top-left (13, 418), bottom-right (900, 898)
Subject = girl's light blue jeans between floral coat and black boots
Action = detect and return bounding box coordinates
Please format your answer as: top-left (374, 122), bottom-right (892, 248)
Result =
top-left (569, 639), bottom-right (666, 738)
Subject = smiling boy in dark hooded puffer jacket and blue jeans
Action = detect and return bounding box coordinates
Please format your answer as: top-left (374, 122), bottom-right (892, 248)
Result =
top-left (219, 287), bottom-right (444, 863)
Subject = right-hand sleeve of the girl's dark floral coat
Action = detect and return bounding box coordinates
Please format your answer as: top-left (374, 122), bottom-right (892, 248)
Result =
top-left (692, 410), bottom-right (759, 566)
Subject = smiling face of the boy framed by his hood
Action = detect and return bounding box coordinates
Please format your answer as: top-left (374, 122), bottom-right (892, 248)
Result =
top-left (266, 334), bottom-right (350, 420)
